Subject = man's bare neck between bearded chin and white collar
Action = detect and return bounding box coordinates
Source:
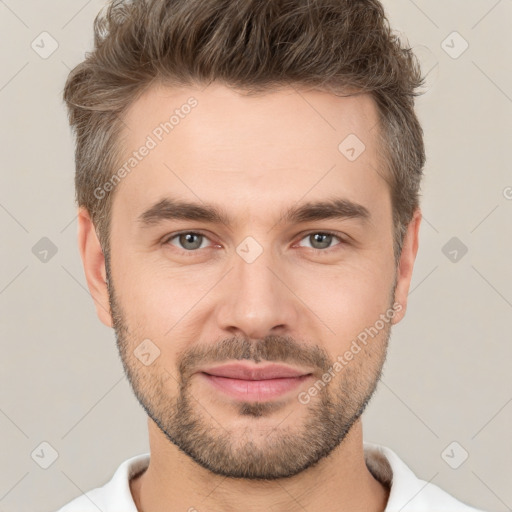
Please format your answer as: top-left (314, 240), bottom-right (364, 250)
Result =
top-left (130, 419), bottom-right (389, 512)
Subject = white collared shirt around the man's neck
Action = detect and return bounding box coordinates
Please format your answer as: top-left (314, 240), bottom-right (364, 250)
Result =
top-left (57, 442), bottom-right (482, 512)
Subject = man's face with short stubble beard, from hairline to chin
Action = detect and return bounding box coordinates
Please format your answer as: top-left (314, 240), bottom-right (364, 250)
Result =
top-left (107, 85), bottom-right (406, 479)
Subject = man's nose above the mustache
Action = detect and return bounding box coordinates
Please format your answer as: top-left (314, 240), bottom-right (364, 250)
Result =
top-left (217, 243), bottom-right (300, 339)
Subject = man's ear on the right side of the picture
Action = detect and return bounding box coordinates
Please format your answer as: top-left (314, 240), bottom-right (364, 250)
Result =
top-left (391, 208), bottom-right (422, 324)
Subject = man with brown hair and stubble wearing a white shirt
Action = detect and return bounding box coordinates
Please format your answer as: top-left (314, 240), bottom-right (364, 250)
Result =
top-left (61, 0), bottom-right (484, 512)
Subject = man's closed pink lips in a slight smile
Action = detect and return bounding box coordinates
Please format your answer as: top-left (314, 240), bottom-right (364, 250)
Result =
top-left (198, 362), bottom-right (313, 402)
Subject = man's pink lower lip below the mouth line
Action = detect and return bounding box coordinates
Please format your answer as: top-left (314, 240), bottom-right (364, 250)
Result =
top-left (200, 373), bottom-right (312, 402)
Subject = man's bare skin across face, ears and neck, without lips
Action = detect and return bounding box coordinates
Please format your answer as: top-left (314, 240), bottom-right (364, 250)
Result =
top-left (78, 84), bottom-right (421, 512)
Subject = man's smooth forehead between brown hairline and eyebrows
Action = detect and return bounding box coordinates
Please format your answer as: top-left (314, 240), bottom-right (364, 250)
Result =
top-left (114, 84), bottom-right (388, 226)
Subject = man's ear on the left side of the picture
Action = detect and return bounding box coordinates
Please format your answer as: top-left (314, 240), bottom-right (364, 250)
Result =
top-left (78, 207), bottom-right (112, 327)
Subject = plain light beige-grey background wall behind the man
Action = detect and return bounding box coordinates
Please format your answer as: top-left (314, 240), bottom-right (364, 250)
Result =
top-left (0, 0), bottom-right (512, 512)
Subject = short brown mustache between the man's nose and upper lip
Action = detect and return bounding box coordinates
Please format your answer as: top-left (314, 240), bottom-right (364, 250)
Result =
top-left (178, 335), bottom-right (332, 380)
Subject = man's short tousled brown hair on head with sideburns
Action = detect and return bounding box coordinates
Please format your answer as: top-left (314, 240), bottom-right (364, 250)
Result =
top-left (64, 0), bottom-right (425, 262)
